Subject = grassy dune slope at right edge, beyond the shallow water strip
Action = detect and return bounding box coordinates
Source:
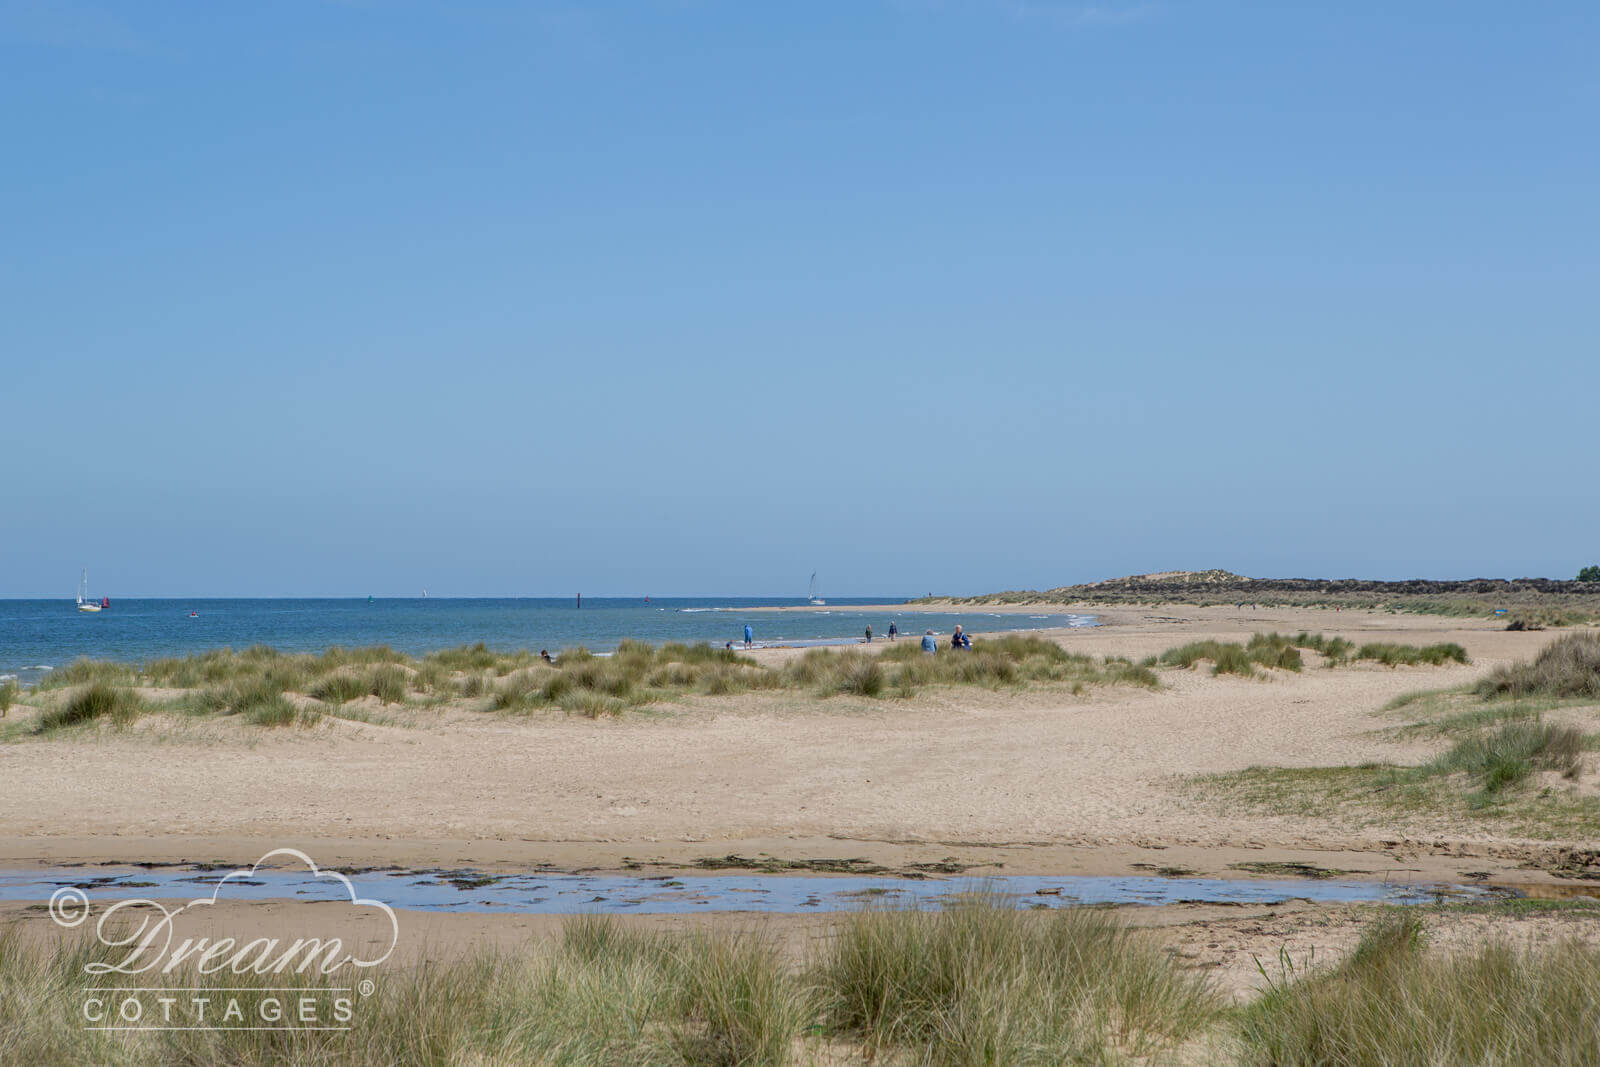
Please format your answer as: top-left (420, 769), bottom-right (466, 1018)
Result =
top-left (1190, 633), bottom-right (1600, 840)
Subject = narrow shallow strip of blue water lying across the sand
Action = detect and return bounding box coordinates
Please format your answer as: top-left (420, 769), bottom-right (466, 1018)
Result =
top-left (0, 864), bottom-right (1504, 915)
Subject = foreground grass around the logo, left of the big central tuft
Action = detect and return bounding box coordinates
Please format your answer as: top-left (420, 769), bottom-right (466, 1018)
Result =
top-left (0, 918), bottom-right (810, 1067)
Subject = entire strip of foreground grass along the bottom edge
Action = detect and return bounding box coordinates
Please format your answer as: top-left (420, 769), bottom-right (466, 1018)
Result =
top-left (9, 896), bottom-right (1600, 1067)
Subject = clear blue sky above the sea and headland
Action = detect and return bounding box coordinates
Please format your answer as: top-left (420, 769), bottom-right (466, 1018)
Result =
top-left (0, 0), bottom-right (1600, 598)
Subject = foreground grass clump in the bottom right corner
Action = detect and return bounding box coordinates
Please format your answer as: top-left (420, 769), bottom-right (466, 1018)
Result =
top-left (1237, 912), bottom-right (1600, 1065)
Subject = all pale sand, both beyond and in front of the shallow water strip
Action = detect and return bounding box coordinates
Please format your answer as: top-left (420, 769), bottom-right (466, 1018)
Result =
top-left (0, 605), bottom-right (1600, 1049)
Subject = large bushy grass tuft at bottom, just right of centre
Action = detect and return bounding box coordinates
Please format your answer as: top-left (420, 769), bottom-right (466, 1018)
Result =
top-left (816, 897), bottom-right (1218, 1064)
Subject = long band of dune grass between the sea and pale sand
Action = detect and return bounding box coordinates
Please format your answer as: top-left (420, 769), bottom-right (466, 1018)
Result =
top-left (9, 635), bottom-right (1158, 733)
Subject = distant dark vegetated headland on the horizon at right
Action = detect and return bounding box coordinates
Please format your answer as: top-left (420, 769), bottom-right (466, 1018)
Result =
top-left (910, 568), bottom-right (1600, 629)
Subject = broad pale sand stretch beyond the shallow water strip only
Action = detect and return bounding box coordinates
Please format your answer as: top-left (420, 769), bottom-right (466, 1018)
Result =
top-left (0, 608), bottom-right (1595, 873)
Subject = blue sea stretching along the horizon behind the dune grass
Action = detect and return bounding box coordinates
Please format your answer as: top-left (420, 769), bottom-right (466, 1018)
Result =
top-left (0, 597), bottom-right (1094, 681)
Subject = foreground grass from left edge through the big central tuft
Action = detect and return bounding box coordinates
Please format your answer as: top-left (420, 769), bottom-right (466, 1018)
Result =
top-left (0, 897), bottom-right (1219, 1067)
